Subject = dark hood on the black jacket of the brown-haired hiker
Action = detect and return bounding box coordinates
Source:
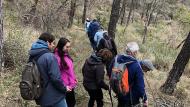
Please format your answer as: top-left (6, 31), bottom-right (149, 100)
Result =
top-left (87, 53), bottom-right (103, 65)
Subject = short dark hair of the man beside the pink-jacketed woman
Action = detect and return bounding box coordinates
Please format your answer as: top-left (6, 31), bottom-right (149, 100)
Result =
top-left (38, 32), bottom-right (55, 43)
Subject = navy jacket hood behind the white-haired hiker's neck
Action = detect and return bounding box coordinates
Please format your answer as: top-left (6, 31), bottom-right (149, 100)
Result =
top-left (117, 55), bottom-right (137, 64)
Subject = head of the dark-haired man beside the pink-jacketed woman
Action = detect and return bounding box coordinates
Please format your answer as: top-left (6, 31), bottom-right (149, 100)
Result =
top-left (38, 32), bottom-right (55, 50)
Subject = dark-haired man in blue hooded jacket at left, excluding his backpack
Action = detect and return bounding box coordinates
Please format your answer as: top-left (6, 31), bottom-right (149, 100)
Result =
top-left (29, 32), bottom-right (71, 107)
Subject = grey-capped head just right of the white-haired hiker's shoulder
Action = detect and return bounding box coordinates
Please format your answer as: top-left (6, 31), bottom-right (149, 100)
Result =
top-left (140, 59), bottom-right (155, 72)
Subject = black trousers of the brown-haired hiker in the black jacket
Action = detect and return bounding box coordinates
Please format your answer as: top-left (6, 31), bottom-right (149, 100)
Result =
top-left (86, 89), bottom-right (103, 107)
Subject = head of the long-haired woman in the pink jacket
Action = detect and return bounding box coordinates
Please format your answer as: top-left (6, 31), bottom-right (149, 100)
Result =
top-left (56, 38), bottom-right (71, 53)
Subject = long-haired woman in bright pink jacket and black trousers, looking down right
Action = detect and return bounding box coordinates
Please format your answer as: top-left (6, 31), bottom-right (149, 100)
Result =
top-left (54, 38), bottom-right (77, 107)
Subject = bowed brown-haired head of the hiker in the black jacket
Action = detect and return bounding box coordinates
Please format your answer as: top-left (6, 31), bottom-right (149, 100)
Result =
top-left (97, 48), bottom-right (113, 63)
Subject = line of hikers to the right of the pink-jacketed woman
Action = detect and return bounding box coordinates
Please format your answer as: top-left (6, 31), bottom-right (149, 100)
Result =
top-left (82, 19), bottom-right (154, 107)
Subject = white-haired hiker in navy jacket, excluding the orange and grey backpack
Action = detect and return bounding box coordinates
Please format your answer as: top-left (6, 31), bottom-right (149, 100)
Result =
top-left (109, 42), bottom-right (148, 107)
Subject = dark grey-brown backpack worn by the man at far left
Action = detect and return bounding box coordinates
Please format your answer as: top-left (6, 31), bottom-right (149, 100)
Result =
top-left (19, 50), bottom-right (49, 100)
